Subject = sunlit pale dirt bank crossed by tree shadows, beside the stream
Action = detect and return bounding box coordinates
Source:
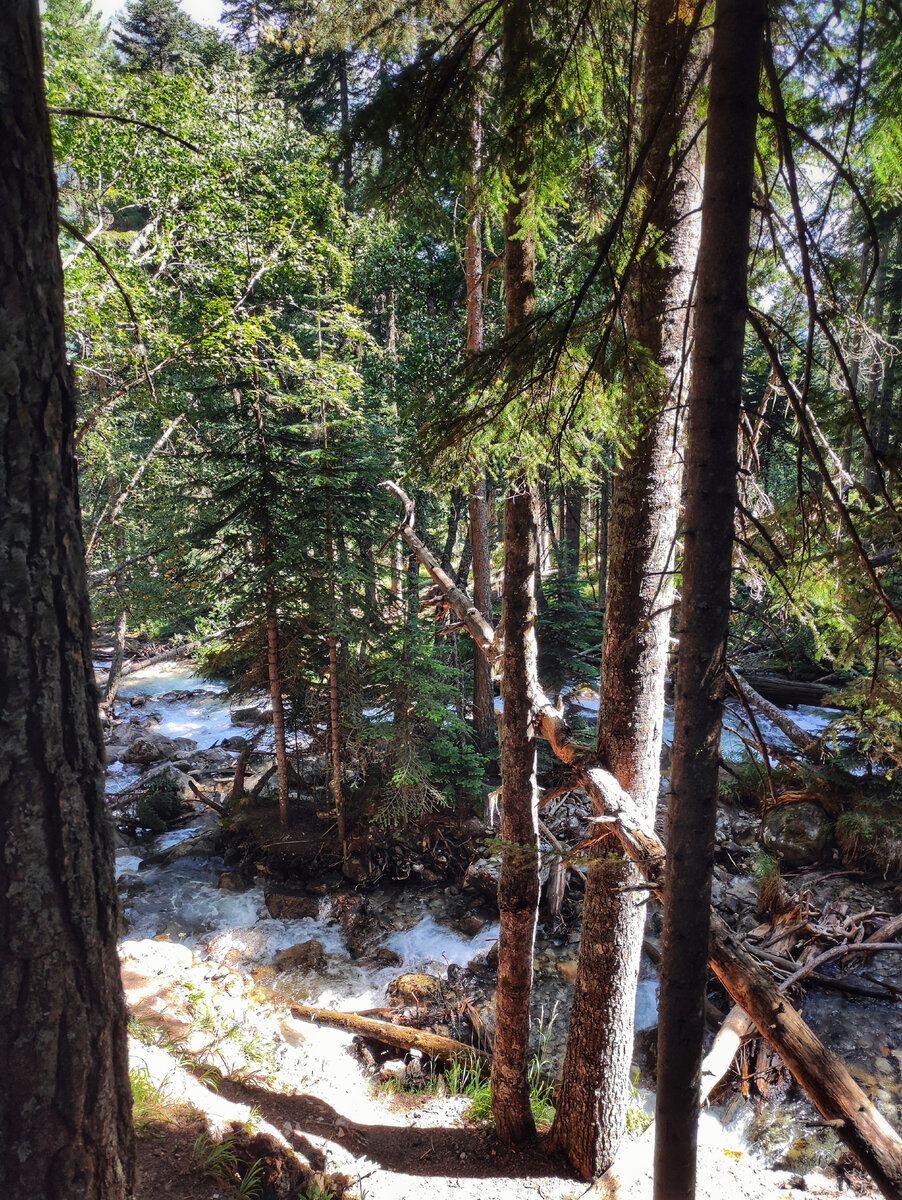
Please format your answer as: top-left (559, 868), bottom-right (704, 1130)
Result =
top-left (122, 941), bottom-right (871, 1200)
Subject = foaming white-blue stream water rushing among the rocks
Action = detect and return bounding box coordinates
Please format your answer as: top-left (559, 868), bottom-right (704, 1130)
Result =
top-left (108, 664), bottom-right (902, 1160)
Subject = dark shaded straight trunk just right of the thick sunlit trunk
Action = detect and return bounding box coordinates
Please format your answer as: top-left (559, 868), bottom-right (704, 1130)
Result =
top-left (655, 0), bottom-right (766, 1200)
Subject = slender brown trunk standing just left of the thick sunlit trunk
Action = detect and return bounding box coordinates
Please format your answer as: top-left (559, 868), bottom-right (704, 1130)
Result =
top-left (492, 0), bottom-right (539, 1144)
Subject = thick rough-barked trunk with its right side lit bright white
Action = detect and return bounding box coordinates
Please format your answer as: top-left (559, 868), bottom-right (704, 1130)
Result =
top-left (554, 0), bottom-right (702, 1178)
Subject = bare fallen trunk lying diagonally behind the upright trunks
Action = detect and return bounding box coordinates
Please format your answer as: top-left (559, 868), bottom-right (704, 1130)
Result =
top-left (384, 482), bottom-right (902, 1200)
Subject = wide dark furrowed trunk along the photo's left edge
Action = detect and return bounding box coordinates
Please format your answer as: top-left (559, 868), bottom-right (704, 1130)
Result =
top-left (0, 7), bottom-right (134, 1200)
